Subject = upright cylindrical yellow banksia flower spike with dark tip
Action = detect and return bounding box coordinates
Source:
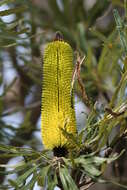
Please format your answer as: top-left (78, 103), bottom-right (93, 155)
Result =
top-left (41, 31), bottom-right (76, 155)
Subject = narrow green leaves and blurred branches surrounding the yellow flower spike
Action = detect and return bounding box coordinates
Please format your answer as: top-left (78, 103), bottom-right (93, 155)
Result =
top-left (0, 0), bottom-right (127, 190)
